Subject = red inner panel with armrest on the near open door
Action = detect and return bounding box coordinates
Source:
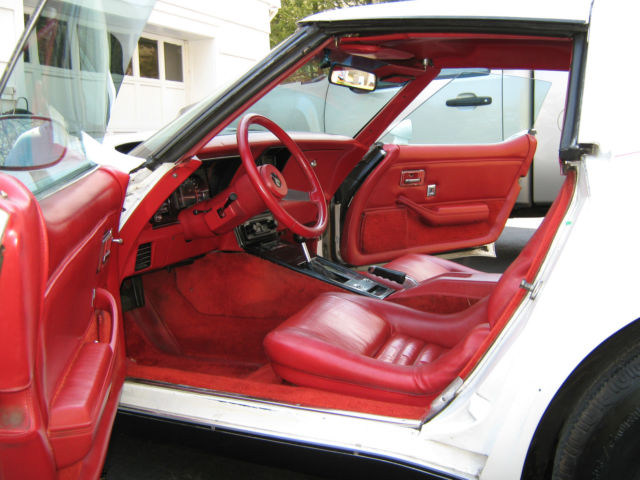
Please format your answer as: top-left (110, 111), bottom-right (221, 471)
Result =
top-left (39, 168), bottom-right (124, 468)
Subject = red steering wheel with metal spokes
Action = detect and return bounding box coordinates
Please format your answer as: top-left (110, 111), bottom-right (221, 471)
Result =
top-left (236, 114), bottom-right (328, 238)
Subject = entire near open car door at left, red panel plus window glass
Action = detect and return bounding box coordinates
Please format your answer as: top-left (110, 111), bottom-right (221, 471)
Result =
top-left (0, 1), bottom-right (152, 479)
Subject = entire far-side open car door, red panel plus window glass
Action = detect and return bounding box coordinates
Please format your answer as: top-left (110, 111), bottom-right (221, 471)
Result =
top-left (340, 72), bottom-right (549, 265)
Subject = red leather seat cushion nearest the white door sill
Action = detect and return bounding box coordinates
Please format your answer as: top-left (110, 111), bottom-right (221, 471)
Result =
top-left (264, 293), bottom-right (489, 406)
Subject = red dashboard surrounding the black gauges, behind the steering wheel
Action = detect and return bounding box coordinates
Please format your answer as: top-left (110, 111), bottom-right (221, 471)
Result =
top-left (120, 137), bottom-right (365, 278)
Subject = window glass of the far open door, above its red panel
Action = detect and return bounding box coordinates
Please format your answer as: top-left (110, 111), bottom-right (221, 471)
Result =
top-left (381, 72), bottom-right (551, 145)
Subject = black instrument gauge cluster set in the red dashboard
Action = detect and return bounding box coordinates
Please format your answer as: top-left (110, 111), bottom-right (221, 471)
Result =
top-left (149, 147), bottom-right (290, 228)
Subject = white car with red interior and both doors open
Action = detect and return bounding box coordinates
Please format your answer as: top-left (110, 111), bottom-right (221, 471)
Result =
top-left (0, 0), bottom-right (640, 479)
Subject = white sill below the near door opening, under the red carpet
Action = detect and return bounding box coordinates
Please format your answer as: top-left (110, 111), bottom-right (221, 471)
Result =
top-left (119, 379), bottom-right (470, 479)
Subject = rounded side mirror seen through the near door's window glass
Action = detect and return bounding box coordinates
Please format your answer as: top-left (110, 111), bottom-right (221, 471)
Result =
top-left (0, 114), bottom-right (69, 170)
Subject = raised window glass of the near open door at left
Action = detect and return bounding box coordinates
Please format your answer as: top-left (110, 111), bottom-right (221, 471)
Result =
top-left (0, 0), bottom-right (155, 193)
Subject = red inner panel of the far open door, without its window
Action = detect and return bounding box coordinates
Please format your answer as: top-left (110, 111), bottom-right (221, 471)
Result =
top-left (341, 135), bottom-right (536, 265)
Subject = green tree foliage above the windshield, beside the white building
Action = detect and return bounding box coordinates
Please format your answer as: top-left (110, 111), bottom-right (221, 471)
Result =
top-left (270, 0), bottom-right (381, 48)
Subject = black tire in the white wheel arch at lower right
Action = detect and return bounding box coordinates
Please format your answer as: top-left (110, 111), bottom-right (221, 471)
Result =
top-left (552, 345), bottom-right (640, 480)
